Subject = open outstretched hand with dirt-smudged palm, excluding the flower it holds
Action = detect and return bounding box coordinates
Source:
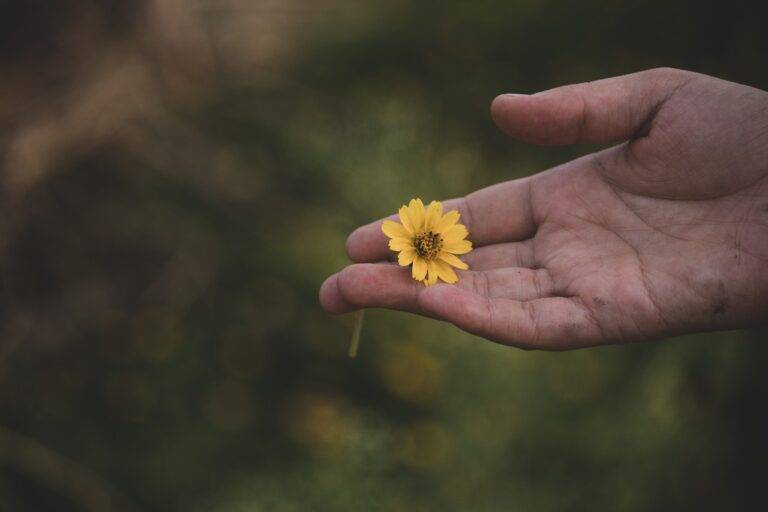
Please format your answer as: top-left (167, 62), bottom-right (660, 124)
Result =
top-left (320, 69), bottom-right (768, 350)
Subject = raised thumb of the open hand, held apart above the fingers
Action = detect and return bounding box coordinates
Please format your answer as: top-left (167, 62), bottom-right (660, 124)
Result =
top-left (491, 68), bottom-right (695, 146)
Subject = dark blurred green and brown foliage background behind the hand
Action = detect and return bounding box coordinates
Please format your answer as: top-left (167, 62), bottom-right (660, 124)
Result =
top-left (0, 0), bottom-right (768, 512)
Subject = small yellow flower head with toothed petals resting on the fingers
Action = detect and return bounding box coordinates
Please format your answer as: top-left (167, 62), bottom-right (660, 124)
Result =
top-left (381, 199), bottom-right (472, 286)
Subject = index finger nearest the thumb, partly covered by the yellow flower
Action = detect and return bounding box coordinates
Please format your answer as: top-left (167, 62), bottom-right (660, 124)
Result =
top-left (347, 177), bottom-right (536, 263)
